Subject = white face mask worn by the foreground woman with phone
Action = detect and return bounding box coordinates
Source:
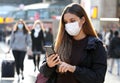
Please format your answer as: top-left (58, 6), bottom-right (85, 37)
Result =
top-left (65, 22), bottom-right (82, 36)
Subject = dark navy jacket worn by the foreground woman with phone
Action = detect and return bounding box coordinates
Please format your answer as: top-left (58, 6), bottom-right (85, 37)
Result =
top-left (40, 37), bottom-right (107, 83)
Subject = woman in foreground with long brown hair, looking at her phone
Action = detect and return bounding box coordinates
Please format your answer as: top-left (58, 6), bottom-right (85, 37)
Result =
top-left (40, 4), bottom-right (107, 83)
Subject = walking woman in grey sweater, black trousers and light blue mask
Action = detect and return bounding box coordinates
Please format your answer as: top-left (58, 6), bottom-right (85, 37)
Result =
top-left (9, 19), bottom-right (32, 81)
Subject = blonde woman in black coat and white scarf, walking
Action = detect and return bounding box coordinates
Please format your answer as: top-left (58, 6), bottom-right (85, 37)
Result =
top-left (31, 20), bottom-right (44, 71)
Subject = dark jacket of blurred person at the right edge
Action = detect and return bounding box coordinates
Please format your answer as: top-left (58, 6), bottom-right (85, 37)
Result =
top-left (108, 36), bottom-right (120, 58)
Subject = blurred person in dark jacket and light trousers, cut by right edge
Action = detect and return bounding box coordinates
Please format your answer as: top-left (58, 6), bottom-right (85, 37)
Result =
top-left (108, 31), bottom-right (120, 75)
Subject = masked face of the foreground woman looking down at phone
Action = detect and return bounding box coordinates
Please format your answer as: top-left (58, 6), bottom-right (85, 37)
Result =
top-left (63, 13), bottom-right (85, 36)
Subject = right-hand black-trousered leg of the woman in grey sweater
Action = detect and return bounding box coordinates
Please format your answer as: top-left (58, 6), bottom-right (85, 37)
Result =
top-left (19, 51), bottom-right (26, 79)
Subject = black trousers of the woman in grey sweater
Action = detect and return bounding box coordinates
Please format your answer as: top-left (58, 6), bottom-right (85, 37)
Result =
top-left (12, 50), bottom-right (26, 75)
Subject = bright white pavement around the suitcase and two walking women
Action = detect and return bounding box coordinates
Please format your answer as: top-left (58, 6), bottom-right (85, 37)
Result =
top-left (0, 43), bottom-right (41, 83)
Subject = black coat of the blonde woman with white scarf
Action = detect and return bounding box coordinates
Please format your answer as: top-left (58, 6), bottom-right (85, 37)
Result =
top-left (31, 29), bottom-right (45, 52)
